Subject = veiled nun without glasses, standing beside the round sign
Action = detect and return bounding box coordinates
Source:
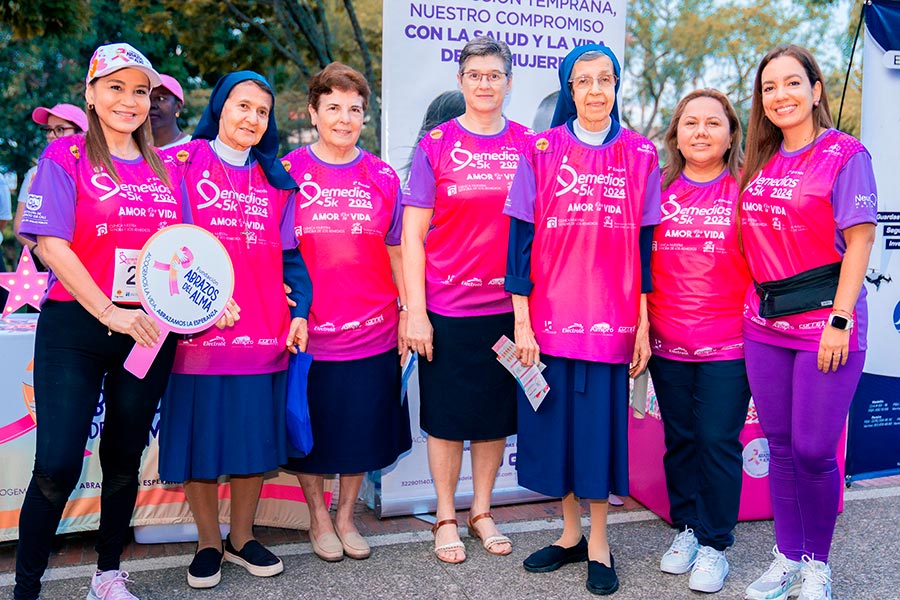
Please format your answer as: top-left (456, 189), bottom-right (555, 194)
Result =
top-left (159, 71), bottom-right (312, 588)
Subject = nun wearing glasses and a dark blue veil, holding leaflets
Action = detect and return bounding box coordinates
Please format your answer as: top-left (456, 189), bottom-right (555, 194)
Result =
top-left (504, 45), bottom-right (660, 595)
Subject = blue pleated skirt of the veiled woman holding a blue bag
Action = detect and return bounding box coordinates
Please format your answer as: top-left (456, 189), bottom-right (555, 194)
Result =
top-left (159, 371), bottom-right (288, 481)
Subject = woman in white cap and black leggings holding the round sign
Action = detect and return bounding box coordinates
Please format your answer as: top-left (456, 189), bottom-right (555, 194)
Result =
top-left (13, 43), bottom-right (182, 600)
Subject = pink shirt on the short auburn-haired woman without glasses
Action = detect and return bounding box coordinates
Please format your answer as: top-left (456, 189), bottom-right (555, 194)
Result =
top-left (282, 147), bottom-right (402, 360)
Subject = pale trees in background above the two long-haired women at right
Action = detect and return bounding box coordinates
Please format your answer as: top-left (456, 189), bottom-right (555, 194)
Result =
top-left (623, 0), bottom-right (834, 152)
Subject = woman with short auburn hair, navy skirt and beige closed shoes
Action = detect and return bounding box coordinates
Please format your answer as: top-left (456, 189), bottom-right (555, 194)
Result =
top-left (282, 63), bottom-right (412, 561)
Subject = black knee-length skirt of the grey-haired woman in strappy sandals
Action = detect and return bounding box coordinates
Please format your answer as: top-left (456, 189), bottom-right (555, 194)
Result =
top-left (419, 312), bottom-right (517, 440)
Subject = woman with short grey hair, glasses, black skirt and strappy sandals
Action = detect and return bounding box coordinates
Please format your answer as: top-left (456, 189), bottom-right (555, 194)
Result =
top-left (401, 37), bottom-right (531, 563)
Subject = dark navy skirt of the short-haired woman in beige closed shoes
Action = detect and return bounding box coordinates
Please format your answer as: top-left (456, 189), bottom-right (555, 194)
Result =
top-left (285, 349), bottom-right (412, 474)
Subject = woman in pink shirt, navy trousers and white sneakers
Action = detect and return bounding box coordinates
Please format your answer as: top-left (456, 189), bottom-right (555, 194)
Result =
top-left (647, 89), bottom-right (750, 592)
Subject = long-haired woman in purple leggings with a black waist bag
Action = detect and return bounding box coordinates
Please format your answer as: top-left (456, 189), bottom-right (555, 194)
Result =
top-left (741, 46), bottom-right (878, 600)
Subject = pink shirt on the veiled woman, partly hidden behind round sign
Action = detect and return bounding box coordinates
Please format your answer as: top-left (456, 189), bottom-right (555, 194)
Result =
top-left (164, 140), bottom-right (297, 375)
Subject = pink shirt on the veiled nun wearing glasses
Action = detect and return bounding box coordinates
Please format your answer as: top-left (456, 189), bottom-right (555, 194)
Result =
top-left (504, 125), bottom-right (660, 364)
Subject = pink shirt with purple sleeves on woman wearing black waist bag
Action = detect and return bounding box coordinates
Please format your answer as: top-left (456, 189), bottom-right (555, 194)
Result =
top-left (741, 129), bottom-right (878, 351)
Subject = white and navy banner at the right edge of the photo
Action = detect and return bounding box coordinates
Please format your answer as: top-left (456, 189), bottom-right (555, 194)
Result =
top-left (847, 0), bottom-right (900, 478)
